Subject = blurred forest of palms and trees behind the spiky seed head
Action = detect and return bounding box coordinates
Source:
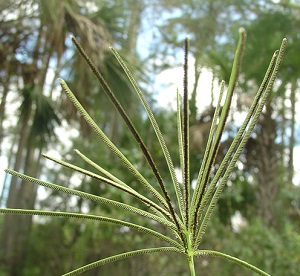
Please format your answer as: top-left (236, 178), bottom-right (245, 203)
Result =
top-left (0, 0), bottom-right (300, 276)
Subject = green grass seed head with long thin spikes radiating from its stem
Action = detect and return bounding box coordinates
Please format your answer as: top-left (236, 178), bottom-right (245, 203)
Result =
top-left (0, 29), bottom-right (286, 275)
